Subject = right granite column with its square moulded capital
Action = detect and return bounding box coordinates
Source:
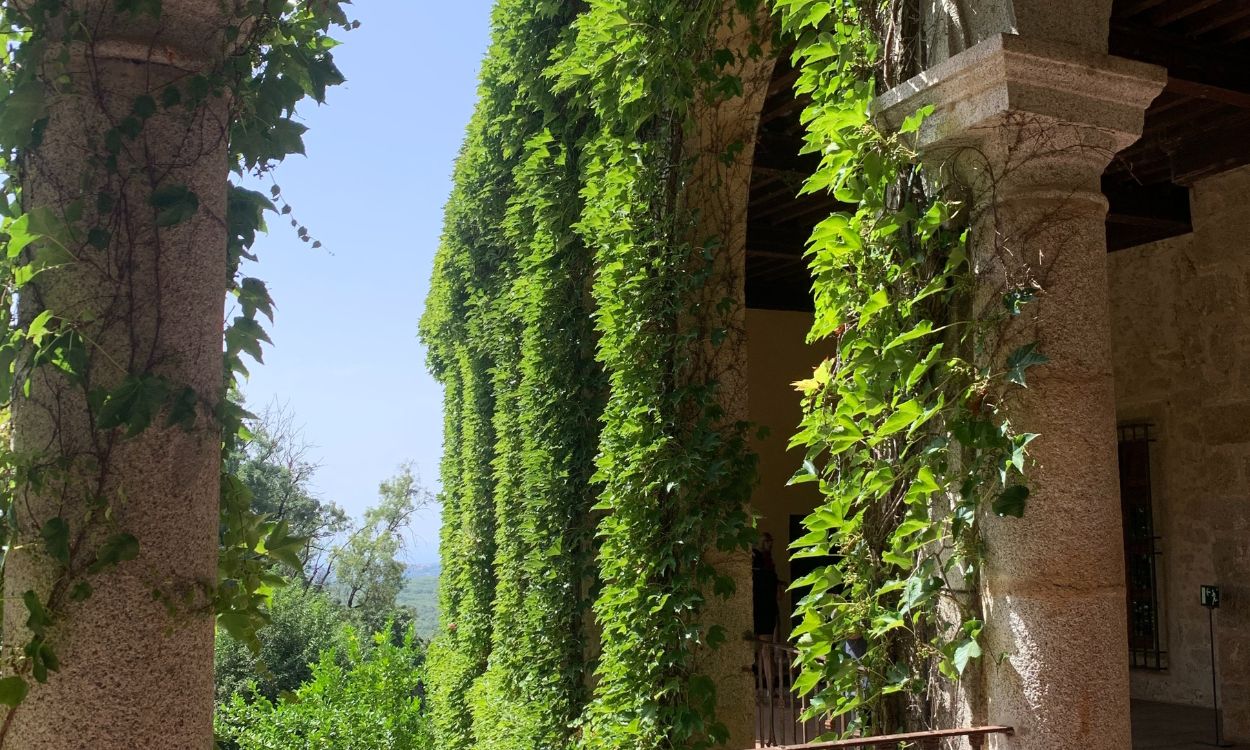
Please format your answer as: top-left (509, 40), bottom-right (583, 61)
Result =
top-left (880, 35), bottom-right (1165, 750)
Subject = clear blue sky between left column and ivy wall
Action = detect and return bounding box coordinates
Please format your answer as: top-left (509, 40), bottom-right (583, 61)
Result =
top-left (245, 0), bottom-right (493, 563)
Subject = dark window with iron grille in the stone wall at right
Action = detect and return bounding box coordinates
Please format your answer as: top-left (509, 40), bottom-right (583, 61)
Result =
top-left (1120, 424), bottom-right (1168, 670)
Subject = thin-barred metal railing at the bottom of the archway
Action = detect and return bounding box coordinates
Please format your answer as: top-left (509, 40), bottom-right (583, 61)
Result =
top-left (755, 643), bottom-right (1013, 750)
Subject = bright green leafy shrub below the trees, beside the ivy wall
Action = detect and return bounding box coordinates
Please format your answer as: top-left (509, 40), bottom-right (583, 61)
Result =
top-left (216, 629), bottom-right (433, 750)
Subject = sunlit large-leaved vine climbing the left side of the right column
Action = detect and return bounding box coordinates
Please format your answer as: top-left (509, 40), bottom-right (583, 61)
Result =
top-left (775, 0), bottom-right (1046, 734)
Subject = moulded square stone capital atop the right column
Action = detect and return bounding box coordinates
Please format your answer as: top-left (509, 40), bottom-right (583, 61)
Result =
top-left (874, 34), bottom-right (1168, 154)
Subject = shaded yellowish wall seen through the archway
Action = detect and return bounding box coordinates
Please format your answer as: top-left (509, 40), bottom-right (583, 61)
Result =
top-left (746, 310), bottom-right (824, 623)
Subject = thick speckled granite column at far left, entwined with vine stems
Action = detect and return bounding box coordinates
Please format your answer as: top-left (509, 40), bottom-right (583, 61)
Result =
top-left (3, 0), bottom-right (228, 750)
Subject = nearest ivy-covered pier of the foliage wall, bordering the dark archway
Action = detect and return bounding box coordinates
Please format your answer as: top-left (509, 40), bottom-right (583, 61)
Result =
top-left (559, 0), bottom-right (761, 750)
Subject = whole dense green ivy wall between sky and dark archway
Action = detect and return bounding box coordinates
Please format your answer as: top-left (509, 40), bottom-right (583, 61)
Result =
top-left (421, 0), bottom-right (754, 750)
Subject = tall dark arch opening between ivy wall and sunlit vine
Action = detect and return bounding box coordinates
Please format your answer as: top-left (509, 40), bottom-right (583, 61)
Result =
top-left (745, 53), bottom-right (845, 746)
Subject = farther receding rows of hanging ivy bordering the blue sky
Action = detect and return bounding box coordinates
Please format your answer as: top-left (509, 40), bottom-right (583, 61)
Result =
top-left (421, 1), bottom-right (599, 749)
